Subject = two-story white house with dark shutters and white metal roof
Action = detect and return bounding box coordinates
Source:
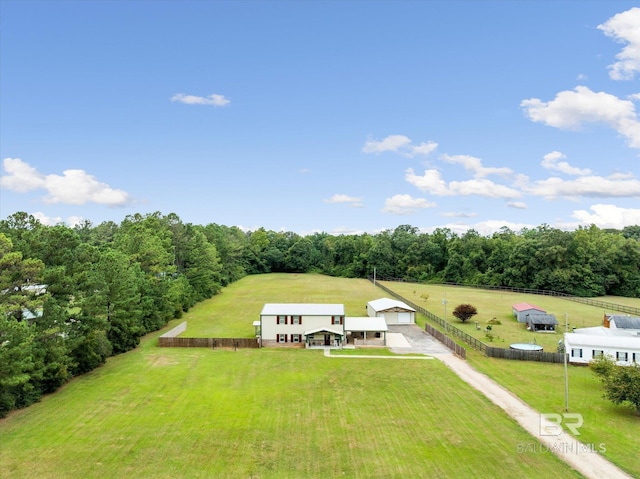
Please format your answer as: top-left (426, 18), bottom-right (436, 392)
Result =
top-left (254, 303), bottom-right (345, 347)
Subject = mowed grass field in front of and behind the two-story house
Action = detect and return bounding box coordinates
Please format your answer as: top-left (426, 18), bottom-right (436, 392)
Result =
top-left (0, 275), bottom-right (580, 478)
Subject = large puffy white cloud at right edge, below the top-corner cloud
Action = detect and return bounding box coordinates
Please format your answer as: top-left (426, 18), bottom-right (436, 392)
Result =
top-left (520, 86), bottom-right (640, 148)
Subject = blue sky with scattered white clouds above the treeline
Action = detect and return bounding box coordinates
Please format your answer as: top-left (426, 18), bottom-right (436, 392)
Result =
top-left (0, 0), bottom-right (640, 234)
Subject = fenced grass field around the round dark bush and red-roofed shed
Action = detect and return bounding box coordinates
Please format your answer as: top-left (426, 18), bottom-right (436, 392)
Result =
top-left (382, 282), bottom-right (640, 352)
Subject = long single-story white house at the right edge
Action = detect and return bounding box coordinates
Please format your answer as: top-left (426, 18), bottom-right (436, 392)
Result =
top-left (564, 326), bottom-right (640, 365)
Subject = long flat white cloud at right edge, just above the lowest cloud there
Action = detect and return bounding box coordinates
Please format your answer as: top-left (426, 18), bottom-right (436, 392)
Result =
top-left (527, 175), bottom-right (640, 199)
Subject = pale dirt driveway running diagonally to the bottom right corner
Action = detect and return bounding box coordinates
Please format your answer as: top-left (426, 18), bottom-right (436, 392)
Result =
top-left (435, 354), bottom-right (633, 479)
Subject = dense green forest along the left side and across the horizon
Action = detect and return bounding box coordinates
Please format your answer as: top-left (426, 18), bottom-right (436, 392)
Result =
top-left (0, 212), bottom-right (640, 417)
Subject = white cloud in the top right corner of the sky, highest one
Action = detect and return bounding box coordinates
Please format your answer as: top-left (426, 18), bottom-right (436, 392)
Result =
top-left (598, 7), bottom-right (640, 80)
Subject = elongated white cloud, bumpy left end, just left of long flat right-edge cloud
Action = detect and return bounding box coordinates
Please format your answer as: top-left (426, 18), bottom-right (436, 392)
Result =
top-left (405, 168), bottom-right (521, 198)
